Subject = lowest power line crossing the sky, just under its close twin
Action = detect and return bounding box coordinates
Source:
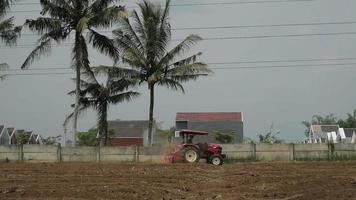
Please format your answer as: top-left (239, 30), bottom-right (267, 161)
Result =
top-left (3, 62), bottom-right (356, 76)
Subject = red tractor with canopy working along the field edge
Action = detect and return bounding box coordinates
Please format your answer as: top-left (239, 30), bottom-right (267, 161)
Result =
top-left (166, 130), bottom-right (226, 165)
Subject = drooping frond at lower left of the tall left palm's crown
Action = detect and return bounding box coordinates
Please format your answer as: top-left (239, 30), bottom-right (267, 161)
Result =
top-left (21, 39), bottom-right (51, 69)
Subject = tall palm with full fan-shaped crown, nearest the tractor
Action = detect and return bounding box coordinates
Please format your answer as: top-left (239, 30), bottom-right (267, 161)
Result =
top-left (113, 0), bottom-right (211, 144)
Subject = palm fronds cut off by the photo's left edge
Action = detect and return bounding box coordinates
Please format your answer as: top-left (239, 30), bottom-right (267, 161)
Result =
top-left (0, 0), bottom-right (21, 80)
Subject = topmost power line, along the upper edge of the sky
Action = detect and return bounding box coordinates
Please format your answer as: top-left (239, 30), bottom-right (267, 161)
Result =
top-left (9, 0), bottom-right (316, 9)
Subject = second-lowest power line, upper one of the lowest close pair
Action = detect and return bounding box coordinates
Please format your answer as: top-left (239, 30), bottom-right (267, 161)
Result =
top-left (4, 57), bottom-right (356, 72)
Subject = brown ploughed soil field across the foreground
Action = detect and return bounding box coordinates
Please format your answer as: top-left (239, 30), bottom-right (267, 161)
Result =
top-left (0, 162), bottom-right (356, 200)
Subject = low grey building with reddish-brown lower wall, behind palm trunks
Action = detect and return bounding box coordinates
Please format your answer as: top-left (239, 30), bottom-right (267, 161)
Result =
top-left (108, 120), bottom-right (156, 146)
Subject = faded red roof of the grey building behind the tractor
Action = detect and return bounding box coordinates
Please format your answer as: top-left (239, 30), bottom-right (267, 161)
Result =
top-left (176, 112), bottom-right (243, 122)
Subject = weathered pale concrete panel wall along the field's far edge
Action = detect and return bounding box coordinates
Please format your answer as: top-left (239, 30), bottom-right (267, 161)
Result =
top-left (0, 144), bottom-right (356, 163)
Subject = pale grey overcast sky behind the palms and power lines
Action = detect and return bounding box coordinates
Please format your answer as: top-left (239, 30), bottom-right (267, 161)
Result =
top-left (0, 0), bottom-right (356, 141)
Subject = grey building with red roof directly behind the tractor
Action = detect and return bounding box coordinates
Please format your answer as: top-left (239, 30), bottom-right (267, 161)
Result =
top-left (176, 112), bottom-right (244, 143)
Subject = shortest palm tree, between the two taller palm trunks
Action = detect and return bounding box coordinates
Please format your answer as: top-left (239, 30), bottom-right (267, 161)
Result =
top-left (65, 67), bottom-right (139, 145)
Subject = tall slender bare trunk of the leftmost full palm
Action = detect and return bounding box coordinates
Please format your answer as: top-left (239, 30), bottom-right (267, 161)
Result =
top-left (73, 32), bottom-right (82, 146)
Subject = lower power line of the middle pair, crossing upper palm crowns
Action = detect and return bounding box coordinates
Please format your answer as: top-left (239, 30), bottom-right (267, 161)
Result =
top-left (0, 31), bottom-right (356, 49)
